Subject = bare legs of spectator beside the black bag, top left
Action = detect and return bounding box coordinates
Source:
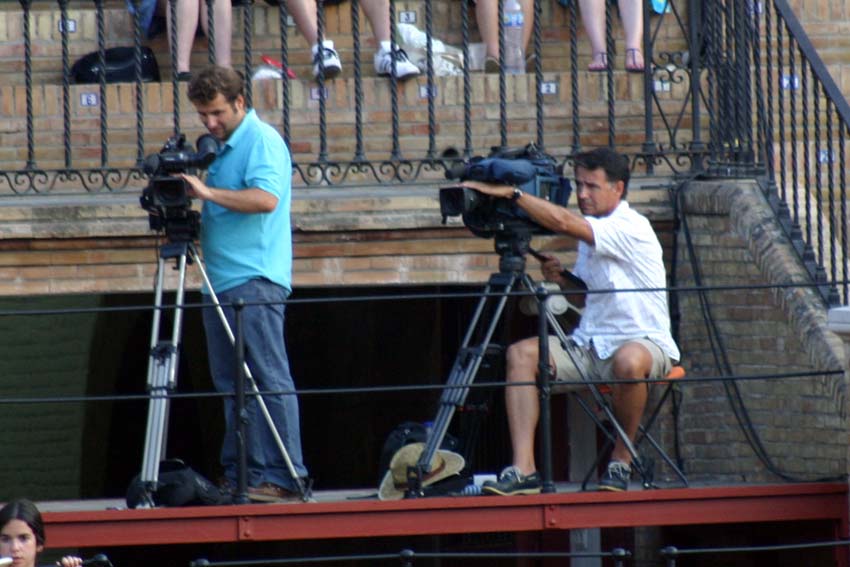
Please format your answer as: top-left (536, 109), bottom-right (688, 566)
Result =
top-left (127, 0), bottom-right (233, 81)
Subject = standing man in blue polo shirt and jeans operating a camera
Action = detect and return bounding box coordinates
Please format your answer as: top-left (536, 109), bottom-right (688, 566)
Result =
top-left (183, 66), bottom-right (307, 501)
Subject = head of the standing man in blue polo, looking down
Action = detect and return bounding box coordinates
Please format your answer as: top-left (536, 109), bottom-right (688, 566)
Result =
top-left (188, 65), bottom-right (246, 140)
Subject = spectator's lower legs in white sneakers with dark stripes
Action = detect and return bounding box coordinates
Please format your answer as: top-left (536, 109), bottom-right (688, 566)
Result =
top-left (286, 0), bottom-right (419, 80)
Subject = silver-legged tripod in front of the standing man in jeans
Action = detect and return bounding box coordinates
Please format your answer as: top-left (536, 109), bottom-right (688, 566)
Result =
top-left (139, 232), bottom-right (310, 508)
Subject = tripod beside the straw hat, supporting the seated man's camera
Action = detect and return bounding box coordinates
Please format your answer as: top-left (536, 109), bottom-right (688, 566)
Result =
top-left (405, 231), bottom-right (643, 498)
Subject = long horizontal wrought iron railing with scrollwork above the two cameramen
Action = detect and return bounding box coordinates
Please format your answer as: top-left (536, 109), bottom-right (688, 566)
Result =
top-left (0, 0), bottom-right (702, 194)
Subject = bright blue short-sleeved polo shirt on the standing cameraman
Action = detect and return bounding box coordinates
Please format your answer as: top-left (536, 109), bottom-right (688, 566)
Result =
top-left (201, 110), bottom-right (292, 298)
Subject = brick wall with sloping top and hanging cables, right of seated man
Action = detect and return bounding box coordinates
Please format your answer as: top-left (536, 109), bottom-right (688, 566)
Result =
top-left (652, 182), bottom-right (848, 482)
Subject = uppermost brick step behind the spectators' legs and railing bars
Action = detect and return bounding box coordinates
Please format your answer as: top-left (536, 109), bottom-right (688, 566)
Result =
top-left (0, 0), bottom-right (684, 84)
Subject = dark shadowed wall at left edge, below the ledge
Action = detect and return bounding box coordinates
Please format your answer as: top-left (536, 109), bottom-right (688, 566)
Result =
top-left (0, 296), bottom-right (99, 501)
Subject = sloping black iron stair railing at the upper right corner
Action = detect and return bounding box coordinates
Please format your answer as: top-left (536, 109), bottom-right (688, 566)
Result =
top-left (693, 0), bottom-right (850, 304)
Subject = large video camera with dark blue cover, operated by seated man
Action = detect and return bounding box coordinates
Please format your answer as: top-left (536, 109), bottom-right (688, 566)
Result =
top-left (440, 144), bottom-right (572, 238)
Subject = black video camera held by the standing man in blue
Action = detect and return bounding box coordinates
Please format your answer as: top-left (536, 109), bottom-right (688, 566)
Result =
top-left (139, 134), bottom-right (218, 241)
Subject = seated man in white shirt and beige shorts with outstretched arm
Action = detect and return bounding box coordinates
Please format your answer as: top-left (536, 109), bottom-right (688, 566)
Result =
top-left (454, 148), bottom-right (679, 495)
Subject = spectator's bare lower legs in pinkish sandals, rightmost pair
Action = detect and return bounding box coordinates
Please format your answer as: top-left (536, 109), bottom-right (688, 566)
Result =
top-left (579, 0), bottom-right (644, 73)
